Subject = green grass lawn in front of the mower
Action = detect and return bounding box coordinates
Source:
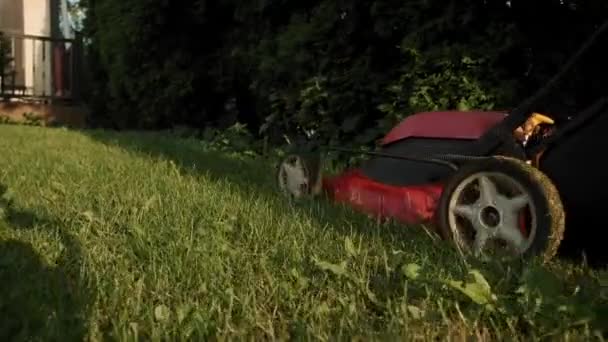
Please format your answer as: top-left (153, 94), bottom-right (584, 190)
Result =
top-left (0, 125), bottom-right (608, 341)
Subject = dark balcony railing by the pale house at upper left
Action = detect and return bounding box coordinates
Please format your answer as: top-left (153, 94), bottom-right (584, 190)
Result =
top-left (0, 31), bottom-right (81, 100)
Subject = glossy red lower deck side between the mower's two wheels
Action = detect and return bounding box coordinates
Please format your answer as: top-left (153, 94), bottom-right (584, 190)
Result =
top-left (323, 170), bottom-right (443, 224)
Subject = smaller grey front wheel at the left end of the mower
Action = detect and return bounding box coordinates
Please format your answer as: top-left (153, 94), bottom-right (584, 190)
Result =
top-left (276, 154), bottom-right (321, 199)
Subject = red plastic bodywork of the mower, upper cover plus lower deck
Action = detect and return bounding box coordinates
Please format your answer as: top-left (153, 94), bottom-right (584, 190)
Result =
top-left (323, 111), bottom-right (506, 224)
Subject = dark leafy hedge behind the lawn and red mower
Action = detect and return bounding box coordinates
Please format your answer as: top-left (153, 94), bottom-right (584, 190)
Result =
top-left (83, 0), bottom-right (608, 144)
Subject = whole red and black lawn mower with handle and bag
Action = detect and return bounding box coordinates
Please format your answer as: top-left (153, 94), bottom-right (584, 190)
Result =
top-left (277, 22), bottom-right (608, 260)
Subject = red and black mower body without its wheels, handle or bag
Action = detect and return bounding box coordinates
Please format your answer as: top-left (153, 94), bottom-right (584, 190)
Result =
top-left (323, 111), bottom-right (506, 224)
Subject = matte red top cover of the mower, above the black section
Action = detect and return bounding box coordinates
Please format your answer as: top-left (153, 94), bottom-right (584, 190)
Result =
top-left (382, 111), bottom-right (506, 145)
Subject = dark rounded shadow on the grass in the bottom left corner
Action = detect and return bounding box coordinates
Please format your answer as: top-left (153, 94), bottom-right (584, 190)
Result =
top-left (0, 204), bottom-right (94, 341)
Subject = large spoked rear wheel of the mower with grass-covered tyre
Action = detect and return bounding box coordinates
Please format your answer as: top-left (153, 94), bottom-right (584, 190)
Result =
top-left (437, 156), bottom-right (565, 261)
